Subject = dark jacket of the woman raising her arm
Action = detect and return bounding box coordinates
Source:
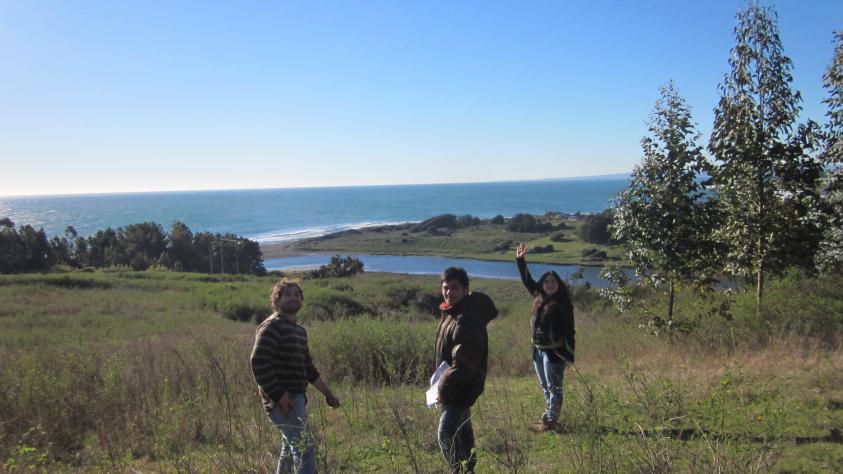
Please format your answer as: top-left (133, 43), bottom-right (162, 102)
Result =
top-left (516, 258), bottom-right (576, 362)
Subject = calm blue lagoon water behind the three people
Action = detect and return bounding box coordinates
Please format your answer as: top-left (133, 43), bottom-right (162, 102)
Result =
top-left (264, 255), bottom-right (633, 288)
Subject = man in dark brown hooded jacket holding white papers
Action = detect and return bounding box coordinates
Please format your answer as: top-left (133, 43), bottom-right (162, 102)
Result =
top-left (436, 267), bottom-right (498, 472)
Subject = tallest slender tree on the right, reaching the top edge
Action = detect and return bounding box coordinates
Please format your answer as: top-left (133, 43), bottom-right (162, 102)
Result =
top-left (709, 3), bottom-right (817, 316)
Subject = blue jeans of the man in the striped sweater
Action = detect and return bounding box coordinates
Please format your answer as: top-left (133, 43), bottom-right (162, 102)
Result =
top-left (269, 393), bottom-right (316, 474)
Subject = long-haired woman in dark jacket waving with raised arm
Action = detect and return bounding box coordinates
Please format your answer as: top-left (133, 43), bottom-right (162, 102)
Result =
top-left (515, 242), bottom-right (576, 431)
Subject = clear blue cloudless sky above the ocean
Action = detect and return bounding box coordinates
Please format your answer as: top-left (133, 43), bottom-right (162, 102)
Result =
top-left (0, 0), bottom-right (843, 195)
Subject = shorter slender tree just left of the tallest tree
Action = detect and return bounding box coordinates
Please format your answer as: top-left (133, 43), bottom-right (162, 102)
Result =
top-left (611, 82), bottom-right (712, 324)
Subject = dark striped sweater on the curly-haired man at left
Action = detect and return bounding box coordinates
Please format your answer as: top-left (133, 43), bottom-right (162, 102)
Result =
top-left (251, 313), bottom-right (319, 411)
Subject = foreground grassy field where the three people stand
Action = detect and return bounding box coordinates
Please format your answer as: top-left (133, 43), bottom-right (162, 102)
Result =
top-left (0, 272), bottom-right (843, 473)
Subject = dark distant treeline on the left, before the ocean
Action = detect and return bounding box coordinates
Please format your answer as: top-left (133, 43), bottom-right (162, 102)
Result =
top-left (0, 218), bottom-right (266, 275)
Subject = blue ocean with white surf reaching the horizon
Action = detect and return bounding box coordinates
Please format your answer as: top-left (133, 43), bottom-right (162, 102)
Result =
top-left (0, 177), bottom-right (627, 242)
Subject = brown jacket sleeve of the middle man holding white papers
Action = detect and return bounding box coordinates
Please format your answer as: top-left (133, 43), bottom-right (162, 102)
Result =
top-left (439, 321), bottom-right (487, 403)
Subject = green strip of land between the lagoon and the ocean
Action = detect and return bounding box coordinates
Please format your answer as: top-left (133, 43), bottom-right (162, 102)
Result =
top-left (290, 219), bottom-right (623, 265)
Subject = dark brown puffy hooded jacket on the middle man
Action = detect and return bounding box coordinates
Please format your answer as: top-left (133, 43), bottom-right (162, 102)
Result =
top-left (436, 292), bottom-right (498, 408)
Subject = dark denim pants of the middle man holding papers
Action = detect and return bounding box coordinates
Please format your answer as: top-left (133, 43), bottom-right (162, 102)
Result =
top-left (439, 405), bottom-right (477, 472)
